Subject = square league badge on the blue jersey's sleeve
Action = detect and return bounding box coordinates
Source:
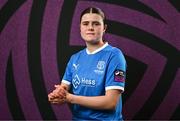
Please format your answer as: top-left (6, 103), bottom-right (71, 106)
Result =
top-left (114, 69), bottom-right (125, 82)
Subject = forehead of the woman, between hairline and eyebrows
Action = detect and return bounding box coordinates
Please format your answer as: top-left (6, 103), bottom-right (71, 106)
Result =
top-left (81, 13), bottom-right (103, 22)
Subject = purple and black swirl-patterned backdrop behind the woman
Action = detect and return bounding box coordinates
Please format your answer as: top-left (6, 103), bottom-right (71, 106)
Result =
top-left (0, 0), bottom-right (180, 120)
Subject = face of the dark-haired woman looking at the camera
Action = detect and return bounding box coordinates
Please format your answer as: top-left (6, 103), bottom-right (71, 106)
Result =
top-left (80, 13), bottom-right (106, 44)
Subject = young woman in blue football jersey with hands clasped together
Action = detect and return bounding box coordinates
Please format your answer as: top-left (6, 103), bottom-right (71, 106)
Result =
top-left (48, 7), bottom-right (126, 120)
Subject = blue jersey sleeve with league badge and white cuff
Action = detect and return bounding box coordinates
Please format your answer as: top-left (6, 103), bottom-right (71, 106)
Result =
top-left (105, 51), bottom-right (126, 92)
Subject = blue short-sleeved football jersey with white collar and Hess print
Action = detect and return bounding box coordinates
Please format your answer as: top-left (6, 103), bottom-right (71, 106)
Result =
top-left (62, 43), bottom-right (126, 120)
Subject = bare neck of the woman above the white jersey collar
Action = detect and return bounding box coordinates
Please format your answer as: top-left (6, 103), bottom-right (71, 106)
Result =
top-left (86, 41), bottom-right (105, 53)
